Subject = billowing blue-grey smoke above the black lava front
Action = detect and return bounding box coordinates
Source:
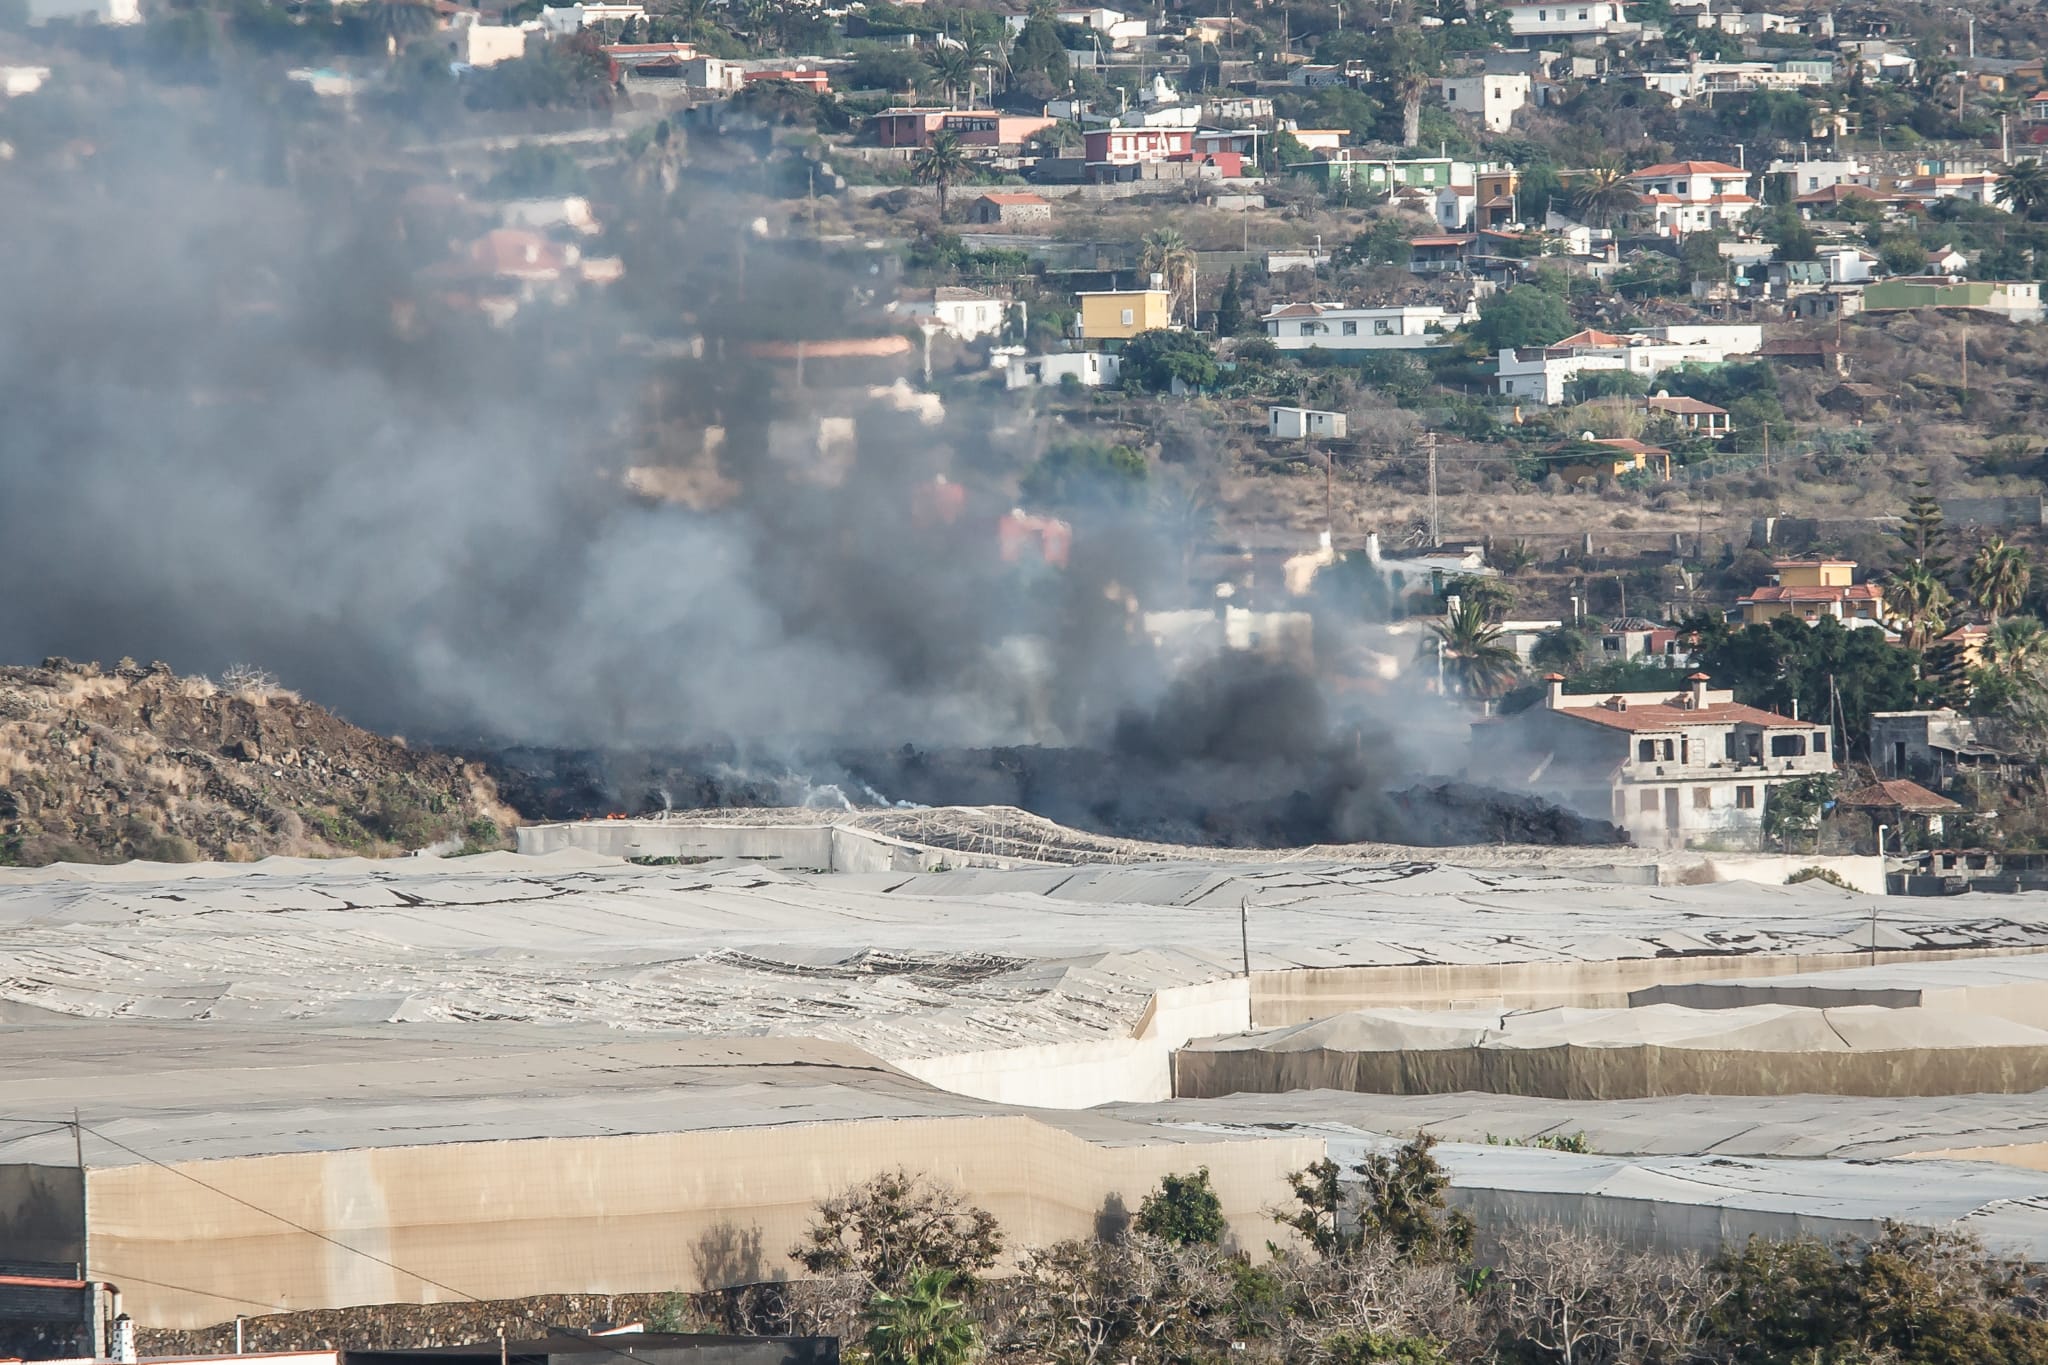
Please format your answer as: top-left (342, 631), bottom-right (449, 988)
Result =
top-left (0, 70), bottom-right (1169, 745)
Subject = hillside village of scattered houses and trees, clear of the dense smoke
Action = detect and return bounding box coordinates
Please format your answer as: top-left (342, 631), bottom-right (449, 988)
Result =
top-left (0, 0), bottom-right (2048, 849)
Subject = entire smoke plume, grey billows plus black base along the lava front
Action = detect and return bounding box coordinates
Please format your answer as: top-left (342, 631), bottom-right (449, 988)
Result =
top-left (0, 69), bottom-right (1608, 845)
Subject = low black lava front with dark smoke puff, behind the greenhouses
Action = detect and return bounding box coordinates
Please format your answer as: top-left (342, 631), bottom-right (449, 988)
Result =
top-left (481, 661), bottom-right (1624, 847)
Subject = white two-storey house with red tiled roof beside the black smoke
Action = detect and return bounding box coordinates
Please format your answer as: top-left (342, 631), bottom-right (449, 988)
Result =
top-left (1473, 673), bottom-right (1835, 847)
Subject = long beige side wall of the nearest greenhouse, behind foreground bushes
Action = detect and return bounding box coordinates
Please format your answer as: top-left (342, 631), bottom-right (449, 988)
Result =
top-left (86, 1117), bottom-right (1323, 1328)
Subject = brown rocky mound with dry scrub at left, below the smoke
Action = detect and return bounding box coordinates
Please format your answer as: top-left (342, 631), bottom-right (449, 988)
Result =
top-left (0, 659), bottom-right (518, 866)
